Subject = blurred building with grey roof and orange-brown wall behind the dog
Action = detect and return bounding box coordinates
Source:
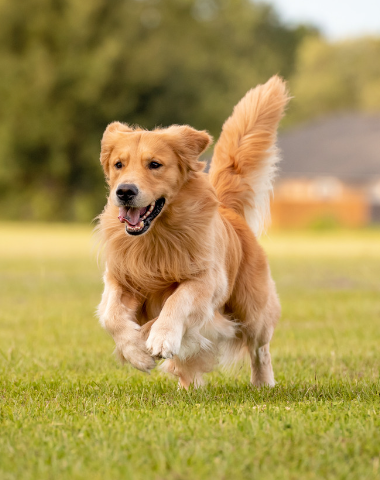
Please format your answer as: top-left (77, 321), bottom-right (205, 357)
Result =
top-left (272, 114), bottom-right (380, 227)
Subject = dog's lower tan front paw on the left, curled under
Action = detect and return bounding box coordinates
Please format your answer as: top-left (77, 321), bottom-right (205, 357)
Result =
top-left (115, 331), bottom-right (156, 372)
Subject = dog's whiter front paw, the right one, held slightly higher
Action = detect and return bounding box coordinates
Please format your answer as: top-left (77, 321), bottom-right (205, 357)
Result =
top-left (146, 320), bottom-right (182, 358)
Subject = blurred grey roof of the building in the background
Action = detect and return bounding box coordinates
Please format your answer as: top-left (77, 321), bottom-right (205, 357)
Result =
top-left (278, 114), bottom-right (380, 182)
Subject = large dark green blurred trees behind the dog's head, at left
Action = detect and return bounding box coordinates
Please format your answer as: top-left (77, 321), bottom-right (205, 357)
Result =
top-left (0, 0), bottom-right (309, 220)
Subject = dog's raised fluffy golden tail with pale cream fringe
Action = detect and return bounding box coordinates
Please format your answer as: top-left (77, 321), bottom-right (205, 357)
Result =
top-left (210, 76), bottom-right (289, 236)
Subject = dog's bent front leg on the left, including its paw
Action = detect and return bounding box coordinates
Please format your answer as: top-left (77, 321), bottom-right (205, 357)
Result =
top-left (98, 271), bottom-right (155, 372)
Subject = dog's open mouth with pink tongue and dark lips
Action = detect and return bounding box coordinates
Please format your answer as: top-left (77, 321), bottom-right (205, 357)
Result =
top-left (118, 198), bottom-right (165, 235)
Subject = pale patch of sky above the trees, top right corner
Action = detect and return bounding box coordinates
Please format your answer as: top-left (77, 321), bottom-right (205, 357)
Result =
top-left (266, 0), bottom-right (380, 40)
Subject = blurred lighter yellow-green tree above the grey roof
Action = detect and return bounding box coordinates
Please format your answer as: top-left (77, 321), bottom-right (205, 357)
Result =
top-left (285, 36), bottom-right (380, 124)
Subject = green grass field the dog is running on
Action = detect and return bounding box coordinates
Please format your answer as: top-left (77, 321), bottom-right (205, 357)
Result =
top-left (0, 224), bottom-right (380, 480)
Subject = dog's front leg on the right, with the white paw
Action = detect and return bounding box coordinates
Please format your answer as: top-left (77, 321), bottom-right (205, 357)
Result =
top-left (146, 279), bottom-right (215, 358)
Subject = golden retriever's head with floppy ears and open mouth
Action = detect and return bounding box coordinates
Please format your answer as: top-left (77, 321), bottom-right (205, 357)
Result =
top-left (100, 122), bottom-right (212, 235)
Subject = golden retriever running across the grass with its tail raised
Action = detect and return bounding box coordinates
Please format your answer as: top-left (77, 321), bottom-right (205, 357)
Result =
top-left (98, 76), bottom-right (288, 388)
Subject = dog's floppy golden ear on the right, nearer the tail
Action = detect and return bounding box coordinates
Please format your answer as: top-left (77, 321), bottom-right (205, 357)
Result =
top-left (167, 125), bottom-right (212, 172)
